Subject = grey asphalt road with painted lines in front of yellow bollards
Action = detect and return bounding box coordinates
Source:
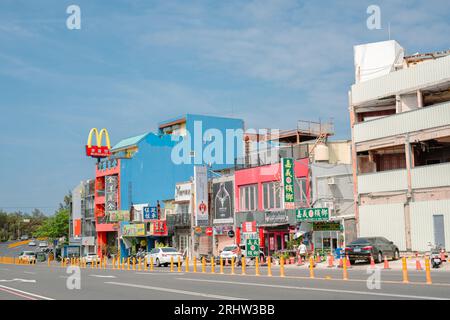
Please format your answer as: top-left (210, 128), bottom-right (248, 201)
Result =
top-left (0, 263), bottom-right (450, 300)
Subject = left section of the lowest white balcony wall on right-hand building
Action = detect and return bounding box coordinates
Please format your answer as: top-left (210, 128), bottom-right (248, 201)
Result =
top-left (358, 169), bottom-right (408, 194)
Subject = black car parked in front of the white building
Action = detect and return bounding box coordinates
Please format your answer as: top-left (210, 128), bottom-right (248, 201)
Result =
top-left (345, 237), bottom-right (400, 264)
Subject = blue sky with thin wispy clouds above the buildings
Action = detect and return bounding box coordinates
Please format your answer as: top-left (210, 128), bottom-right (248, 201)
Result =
top-left (0, 0), bottom-right (450, 213)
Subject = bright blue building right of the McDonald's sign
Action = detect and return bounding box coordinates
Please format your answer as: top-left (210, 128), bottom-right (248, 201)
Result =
top-left (106, 114), bottom-right (244, 257)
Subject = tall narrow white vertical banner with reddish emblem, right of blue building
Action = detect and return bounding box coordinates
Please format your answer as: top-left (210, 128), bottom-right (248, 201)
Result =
top-left (194, 166), bottom-right (208, 226)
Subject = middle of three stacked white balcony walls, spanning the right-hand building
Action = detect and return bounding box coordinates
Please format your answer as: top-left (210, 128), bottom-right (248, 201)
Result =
top-left (353, 102), bottom-right (450, 143)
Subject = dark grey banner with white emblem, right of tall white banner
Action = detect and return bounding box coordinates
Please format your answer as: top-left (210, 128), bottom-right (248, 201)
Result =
top-left (213, 181), bottom-right (234, 223)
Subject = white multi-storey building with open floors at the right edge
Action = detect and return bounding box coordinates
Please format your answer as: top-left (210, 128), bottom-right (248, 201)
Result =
top-left (349, 41), bottom-right (450, 251)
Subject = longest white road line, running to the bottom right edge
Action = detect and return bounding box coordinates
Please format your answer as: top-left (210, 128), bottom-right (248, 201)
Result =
top-left (176, 278), bottom-right (449, 300)
